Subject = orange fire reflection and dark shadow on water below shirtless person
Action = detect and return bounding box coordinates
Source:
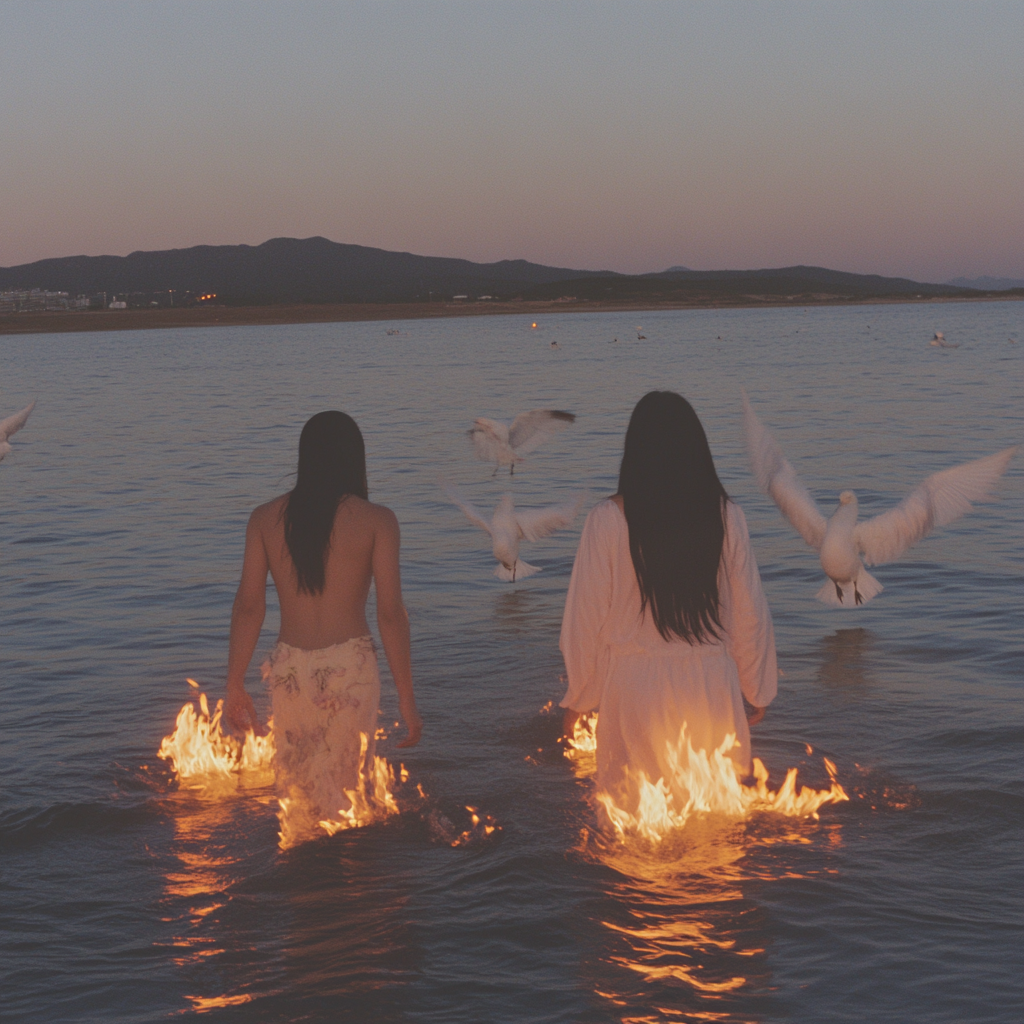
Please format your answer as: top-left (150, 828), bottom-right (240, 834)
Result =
top-left (163, 765), bottom-right (418, 1021)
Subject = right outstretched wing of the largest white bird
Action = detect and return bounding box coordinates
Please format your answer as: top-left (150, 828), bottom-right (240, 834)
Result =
top-left (853, 446), bottom-right (1018, 565)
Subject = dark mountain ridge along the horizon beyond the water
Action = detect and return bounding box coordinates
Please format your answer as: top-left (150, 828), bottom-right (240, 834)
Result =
top-left (0, 238), bottom-right (981, 305)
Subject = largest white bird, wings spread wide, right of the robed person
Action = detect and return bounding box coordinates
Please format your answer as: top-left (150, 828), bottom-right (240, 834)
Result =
top-left (743, 391), bottom-right (1018, 607)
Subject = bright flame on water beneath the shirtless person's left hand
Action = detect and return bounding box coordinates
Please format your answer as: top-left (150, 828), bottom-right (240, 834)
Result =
top-left (157, 679), bottom-right (274, 788)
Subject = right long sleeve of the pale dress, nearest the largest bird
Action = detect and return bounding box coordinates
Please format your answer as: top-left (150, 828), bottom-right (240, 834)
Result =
top-left (722, 502), bottom-right (778, 708)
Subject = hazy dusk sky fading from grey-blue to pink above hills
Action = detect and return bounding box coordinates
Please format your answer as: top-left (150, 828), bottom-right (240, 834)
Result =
top-left (0, 0), bottom-right (1024, 281)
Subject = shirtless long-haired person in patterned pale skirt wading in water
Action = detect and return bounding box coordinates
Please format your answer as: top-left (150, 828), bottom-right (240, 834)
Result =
top-left (224, 412), bottom-right (423, 845)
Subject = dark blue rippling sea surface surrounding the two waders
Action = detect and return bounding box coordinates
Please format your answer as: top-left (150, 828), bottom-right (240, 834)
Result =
top-left (0, 302), bottom-right (1024, 1024)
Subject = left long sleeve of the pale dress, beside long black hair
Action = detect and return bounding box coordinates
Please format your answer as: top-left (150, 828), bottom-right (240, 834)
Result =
top-left (558, 505), bottom-right (616, 712)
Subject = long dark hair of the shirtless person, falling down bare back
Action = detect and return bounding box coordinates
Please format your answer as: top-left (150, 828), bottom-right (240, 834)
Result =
top-left (285, 411), bottom-right (367, 594)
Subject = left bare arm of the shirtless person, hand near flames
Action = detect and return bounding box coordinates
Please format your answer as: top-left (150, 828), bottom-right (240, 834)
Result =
top-left (224, 508), bottom-right (269, 732)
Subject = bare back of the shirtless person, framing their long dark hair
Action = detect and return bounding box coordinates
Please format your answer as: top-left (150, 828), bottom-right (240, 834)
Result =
top-left (251, 495), bottom-right (397, 650)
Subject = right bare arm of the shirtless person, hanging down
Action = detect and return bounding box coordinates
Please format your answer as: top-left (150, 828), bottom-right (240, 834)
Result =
top-left (373, 509), bottom-right (423, 748)
